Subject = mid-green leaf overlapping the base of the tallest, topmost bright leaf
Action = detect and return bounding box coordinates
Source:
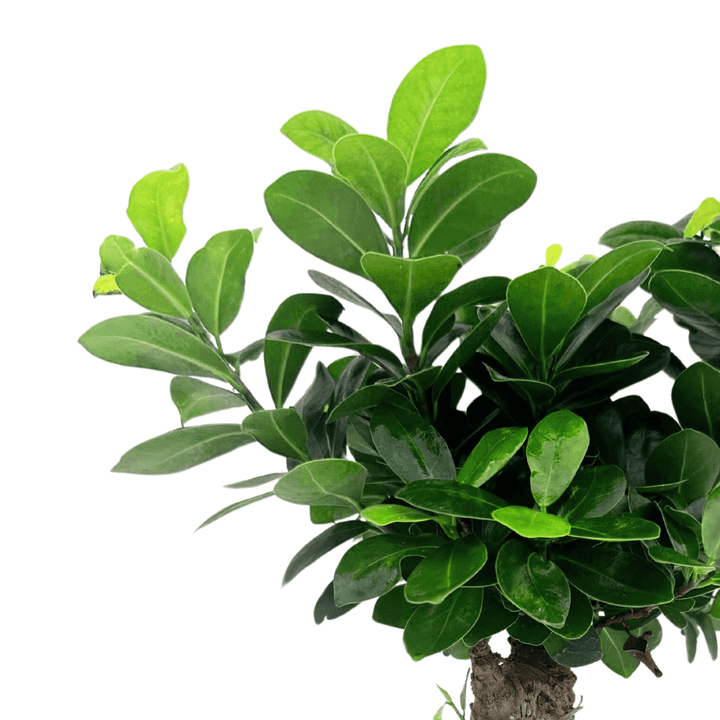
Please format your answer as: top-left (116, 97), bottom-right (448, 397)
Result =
top-left (333, 133), bottom-right (408, 228)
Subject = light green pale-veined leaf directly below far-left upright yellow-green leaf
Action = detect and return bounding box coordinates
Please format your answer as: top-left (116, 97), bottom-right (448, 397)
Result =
top-left (115, 248), bottom-right (192, 318)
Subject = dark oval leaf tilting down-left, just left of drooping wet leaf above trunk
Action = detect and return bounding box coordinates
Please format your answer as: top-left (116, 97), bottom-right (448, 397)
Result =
top-left (405, 534), bottom-right (488, 605)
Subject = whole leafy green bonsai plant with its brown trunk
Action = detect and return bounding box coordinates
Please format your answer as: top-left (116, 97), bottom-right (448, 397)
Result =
top-left (79, 45), bottom-right (720, 720)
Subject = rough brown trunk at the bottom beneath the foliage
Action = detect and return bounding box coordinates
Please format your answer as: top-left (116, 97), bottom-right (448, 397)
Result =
top-left (470, 637), bottom-right (577, 720)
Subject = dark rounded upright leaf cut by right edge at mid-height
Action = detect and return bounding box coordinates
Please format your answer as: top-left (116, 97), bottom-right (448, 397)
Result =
top-left (671, 362), bottom-right (720, 445)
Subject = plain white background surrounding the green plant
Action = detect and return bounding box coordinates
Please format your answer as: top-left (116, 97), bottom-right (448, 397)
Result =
top-left (0, 0), bottom-right (720, 720)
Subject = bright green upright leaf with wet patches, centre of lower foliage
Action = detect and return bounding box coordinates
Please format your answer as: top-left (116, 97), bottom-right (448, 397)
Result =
top-left (525, 410), bottom-right (590, 507)
